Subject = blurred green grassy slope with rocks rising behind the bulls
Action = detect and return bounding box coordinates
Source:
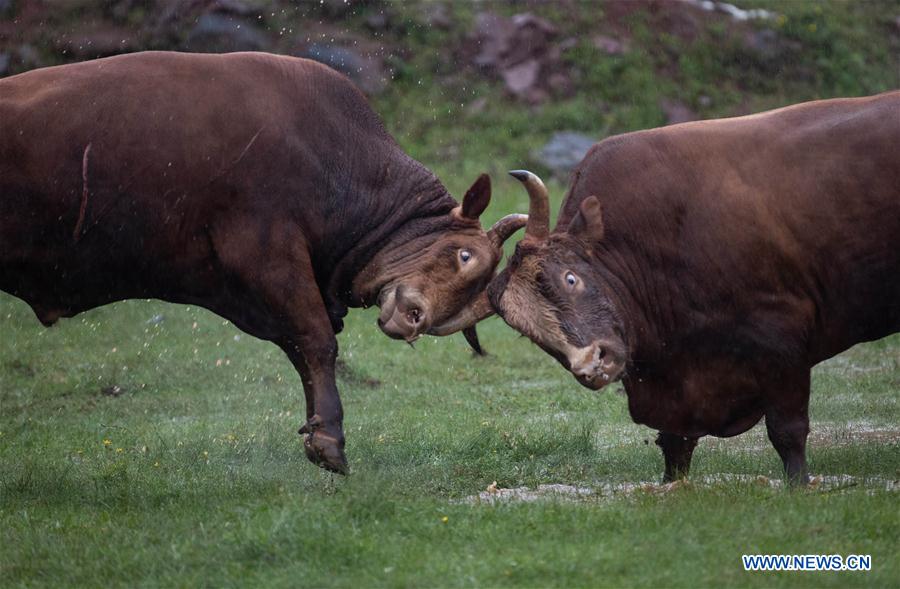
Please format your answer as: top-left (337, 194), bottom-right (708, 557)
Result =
top-left (358, 0), bottom-right (900, 181)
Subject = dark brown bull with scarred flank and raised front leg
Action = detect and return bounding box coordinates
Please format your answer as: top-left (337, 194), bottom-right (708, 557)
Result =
top-left (0, 53), bottom-right (524, 472)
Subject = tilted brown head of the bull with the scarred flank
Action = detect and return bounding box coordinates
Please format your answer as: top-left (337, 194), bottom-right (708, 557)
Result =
top-left (360, 174), bottom-right (527, 342)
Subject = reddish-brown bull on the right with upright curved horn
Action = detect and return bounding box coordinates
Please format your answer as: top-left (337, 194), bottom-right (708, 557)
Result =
top-left (488, 92), bottom-right (900, 482)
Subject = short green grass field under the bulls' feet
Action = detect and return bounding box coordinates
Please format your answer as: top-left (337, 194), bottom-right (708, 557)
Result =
top-left (0, 296), bottom-right (900, 586)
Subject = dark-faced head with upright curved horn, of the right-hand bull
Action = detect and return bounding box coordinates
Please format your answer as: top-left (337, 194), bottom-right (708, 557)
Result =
top-left (487, 170), bottom-right (628, 389)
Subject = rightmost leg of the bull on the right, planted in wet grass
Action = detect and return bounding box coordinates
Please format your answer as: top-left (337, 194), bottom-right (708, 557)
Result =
top-left (765, 370), bottom-right (809, 485)
